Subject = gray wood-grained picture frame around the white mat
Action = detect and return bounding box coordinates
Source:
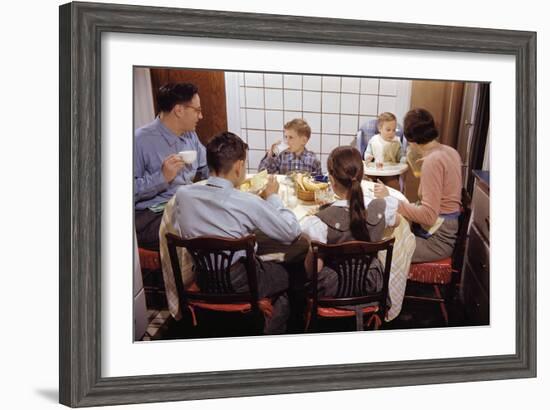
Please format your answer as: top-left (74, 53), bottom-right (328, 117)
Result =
top-left (59, 3), bottom-right (536, 407)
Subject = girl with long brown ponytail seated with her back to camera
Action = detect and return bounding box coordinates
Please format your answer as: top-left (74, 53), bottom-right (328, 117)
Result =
top-left (301, 146), bottom-right (399, 296)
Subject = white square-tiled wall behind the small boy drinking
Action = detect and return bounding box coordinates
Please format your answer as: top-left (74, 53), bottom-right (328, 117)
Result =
top-left (238, 73), bottom-right (412, 172)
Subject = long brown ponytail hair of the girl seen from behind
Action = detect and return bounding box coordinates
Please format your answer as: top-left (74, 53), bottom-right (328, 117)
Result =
top-left (327, 146), bottom-right (370, 242)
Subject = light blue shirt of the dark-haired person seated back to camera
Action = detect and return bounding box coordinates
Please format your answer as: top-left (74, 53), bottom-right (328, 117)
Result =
top-left (175, 176), bottom-right (301, 260)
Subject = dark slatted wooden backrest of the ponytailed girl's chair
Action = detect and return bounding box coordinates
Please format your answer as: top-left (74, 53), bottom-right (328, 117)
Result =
top-left (311, 238), bottom-right (395, 317)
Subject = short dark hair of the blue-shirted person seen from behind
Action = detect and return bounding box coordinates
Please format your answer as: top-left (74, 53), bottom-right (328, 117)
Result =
top-left (206, 131), bottom-right (248, 174)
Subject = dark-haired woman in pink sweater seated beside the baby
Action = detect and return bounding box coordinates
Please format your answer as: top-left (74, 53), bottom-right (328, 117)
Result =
top-left (374, 108), bottom-right (462, 262)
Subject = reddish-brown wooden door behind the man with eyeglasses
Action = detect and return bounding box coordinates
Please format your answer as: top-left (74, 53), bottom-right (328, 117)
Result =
top-left (151, 68), bottom-right (227, 145)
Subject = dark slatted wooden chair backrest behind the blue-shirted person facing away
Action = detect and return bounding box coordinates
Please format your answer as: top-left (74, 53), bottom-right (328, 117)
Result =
top-left (166, 233), bottom-right (258, 310)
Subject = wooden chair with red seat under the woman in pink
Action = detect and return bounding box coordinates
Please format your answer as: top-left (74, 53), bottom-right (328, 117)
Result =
top-left (405, 189), bottom-right (472, 325)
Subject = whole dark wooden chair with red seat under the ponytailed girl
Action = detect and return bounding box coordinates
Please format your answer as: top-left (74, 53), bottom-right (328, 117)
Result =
top-left (306, 238), bottom-right (395, 330)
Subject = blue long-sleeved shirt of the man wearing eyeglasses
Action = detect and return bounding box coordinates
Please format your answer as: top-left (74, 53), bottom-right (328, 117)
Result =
top-left (134, 118), bottom-right (208, 210)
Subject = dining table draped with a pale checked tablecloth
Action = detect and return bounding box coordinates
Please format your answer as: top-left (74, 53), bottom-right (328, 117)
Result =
top-left (159, 175), bottom-right (416, 321)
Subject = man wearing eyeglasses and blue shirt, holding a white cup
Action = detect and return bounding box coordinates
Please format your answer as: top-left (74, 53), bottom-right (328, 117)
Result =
top-left (134, 83), bottom-right (208, 250)
